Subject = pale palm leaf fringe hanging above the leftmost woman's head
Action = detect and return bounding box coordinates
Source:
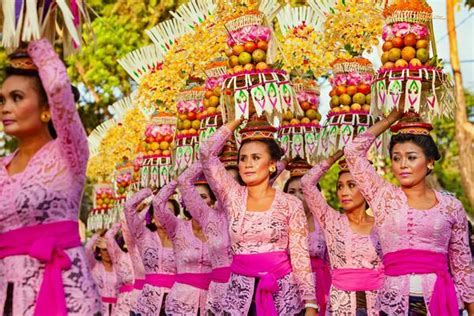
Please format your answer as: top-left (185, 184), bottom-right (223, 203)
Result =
top-left (0, 0), bottom-right (90, 54)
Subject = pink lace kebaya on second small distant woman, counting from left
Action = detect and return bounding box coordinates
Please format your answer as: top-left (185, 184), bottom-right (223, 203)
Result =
top-left (105, 224), bottom-right (134, 316)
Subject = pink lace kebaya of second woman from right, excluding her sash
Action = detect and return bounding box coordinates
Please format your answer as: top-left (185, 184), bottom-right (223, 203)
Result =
top-left (301, 161), bottom-right (382, 316)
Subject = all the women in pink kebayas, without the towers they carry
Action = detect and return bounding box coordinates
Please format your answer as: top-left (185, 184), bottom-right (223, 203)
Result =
top-left (0, 40), bottom-right (474, 315)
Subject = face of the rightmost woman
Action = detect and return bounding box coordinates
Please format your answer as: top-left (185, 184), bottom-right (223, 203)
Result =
top-left (392, 142), bottom-right (433, 187)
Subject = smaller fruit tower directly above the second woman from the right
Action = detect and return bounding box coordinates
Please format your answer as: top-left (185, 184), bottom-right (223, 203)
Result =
top-left (317, 57), bottom-right (384, 157)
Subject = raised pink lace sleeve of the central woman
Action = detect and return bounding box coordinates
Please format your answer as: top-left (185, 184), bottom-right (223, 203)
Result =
top-left (199, 125), bottom-right (240, 210)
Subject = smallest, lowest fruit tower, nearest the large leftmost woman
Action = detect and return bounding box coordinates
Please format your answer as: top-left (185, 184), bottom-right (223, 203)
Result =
top-left (87, 183), bottom-right (115, 231)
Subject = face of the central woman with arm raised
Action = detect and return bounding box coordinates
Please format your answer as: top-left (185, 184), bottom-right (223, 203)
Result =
top-left (239, 142), bottom-right (275, 186)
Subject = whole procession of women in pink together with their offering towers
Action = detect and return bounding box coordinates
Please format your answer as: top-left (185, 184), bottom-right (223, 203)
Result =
top-left (0, 0), bottom-right (474, 316)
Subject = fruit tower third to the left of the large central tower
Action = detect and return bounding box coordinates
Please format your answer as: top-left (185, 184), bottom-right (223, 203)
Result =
top-left (139, 112), bottom-right (177, 190)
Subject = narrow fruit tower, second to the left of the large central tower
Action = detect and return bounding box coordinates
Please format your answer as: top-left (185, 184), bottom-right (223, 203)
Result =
top-left (174, 83), bottom-right (205, 175)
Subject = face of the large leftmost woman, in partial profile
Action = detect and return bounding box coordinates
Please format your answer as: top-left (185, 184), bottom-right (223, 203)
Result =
top-left (0, 76), bottom-right (48, 137)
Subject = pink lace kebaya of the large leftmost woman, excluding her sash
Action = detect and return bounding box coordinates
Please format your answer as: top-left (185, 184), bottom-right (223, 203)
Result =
top-left (0, 40), bottom-right (101, 315)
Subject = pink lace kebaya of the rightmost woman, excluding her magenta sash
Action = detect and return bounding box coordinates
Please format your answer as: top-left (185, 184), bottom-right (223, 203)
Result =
top-left (345, 132), bottom-right (474, 315)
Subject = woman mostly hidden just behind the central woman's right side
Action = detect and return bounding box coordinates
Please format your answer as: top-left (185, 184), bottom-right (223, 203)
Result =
top-left (283, 158), bottom-right (331, 315)
